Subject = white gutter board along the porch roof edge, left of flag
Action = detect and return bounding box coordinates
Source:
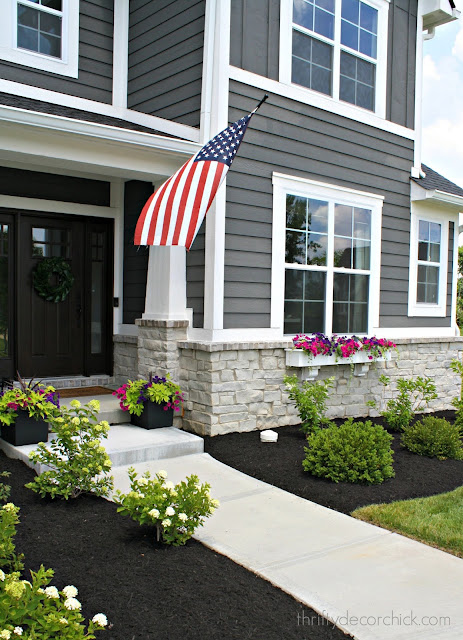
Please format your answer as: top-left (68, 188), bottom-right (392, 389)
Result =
top-left (0, 105), bottom-right (200, 155)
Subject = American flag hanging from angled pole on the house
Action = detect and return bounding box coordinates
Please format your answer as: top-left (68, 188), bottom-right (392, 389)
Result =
top-left (134, 107), bottom-right (263, 251)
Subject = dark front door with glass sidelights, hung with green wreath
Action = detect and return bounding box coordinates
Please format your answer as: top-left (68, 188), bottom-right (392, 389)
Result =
top-left (0, 212), bottom-right (112, 378)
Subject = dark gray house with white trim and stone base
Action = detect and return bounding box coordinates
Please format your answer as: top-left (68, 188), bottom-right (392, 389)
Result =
top-left (0, 0), bottom-right (463, 434)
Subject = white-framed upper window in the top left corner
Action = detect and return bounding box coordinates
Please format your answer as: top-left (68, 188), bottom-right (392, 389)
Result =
top-left (0, 0), bottom-right (79, 77)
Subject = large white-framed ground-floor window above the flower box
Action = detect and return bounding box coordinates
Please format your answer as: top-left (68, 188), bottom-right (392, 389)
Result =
top-left (272, 174), bottom-right (382, 335)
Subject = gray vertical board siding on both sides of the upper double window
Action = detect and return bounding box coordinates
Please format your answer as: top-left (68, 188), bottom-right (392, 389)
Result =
top-left (230, 0), bottom-right (418, 128)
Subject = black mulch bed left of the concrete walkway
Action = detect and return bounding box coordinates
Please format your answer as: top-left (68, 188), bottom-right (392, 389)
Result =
top-left (0, 450), bottom-right (350, 640)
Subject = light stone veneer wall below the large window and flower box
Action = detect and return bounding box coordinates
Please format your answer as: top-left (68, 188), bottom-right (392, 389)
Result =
top-left (178, 338), bottom-right (463, 435)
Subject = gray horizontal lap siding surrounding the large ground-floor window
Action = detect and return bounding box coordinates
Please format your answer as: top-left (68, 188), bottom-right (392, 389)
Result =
top-left (224, 81), bottom-right (451, 328)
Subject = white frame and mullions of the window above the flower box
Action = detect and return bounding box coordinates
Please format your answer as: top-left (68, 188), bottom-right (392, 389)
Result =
top-left (271, 172), bottom-right (384, 335)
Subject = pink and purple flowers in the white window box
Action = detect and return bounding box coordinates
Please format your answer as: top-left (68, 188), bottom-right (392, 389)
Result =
top-left (293, 333), bottom-right (397, 360)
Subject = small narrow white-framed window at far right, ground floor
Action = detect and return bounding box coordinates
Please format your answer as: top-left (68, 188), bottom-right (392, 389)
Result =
top-left (408, 214), bottom-right (448, 316)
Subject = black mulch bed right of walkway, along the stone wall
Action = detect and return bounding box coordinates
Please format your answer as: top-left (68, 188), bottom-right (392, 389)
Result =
top-left (204, 412), bottom-right (463, 514)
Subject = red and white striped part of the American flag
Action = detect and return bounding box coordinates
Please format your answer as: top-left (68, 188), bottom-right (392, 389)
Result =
top-left (135, 156), bottom-right (228, 251)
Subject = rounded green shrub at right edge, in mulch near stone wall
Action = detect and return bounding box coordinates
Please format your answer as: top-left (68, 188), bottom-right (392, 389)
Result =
top-left (401, 416), bottom-right (463, 460)
